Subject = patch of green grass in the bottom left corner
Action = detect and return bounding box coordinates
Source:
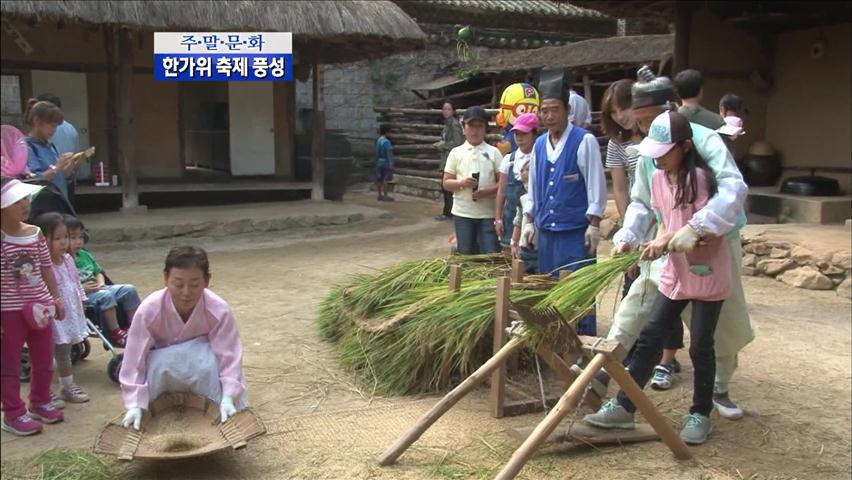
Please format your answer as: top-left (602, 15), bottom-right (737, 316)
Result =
top-left (2, 448), bottom-right (118, 480)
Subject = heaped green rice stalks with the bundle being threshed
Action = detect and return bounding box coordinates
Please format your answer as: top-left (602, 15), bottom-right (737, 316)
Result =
top-left (319, 255), bottom-right (635, 395)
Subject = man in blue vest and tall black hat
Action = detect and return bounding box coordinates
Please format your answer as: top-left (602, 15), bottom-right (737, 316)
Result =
top-left (522, 68), bottom-right (606, 335)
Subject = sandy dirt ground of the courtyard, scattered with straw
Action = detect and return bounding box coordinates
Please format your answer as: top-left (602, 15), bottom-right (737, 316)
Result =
top-left (0, 194), bottom-right (852, 480)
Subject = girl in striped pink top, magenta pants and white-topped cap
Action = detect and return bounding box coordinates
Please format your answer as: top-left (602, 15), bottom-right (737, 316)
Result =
top-left (0, 177), bottom-right (65, 436)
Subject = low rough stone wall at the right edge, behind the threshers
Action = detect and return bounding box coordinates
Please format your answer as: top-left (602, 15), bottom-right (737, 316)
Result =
top-left (742, 234), bottom-right (852, 298)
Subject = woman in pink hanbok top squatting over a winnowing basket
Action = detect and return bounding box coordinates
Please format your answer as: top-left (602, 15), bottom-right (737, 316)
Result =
top-left (119, 247), bottom-right (247, 430)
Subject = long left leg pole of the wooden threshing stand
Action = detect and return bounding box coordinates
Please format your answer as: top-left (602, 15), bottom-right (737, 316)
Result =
top-left (378, 337), bottom-right (524, 465)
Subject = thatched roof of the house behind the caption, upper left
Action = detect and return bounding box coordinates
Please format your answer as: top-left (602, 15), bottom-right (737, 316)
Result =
top-left (0, 0), bottom-right (426, 63)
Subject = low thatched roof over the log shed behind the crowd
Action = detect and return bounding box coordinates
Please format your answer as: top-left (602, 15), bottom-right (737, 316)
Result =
top-left (479, 35), bottom-right (674, 73)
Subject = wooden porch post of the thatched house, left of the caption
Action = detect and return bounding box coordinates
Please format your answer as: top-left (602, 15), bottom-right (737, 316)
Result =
top-left (116, 28), bottom-right (139, 212)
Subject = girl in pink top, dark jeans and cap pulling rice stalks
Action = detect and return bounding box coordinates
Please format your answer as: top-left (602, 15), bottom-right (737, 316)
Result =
top-left (585, 112), bottom-right (731, 444)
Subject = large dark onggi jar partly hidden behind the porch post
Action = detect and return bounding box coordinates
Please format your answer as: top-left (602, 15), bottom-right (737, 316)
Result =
top-left (296, 130), bottom-right (353, 201)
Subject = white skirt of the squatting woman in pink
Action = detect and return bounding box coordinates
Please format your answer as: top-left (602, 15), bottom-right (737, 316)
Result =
top-left (146, 336), bottom-right (248, 411)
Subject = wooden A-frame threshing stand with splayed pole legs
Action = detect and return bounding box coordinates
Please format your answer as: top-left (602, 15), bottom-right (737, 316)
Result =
top-left (378, 268), bottom-right (692, 480)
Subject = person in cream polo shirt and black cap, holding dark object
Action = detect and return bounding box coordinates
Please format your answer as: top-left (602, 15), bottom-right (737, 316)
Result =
top-left (443, 106), bottom-right (503, 255)
